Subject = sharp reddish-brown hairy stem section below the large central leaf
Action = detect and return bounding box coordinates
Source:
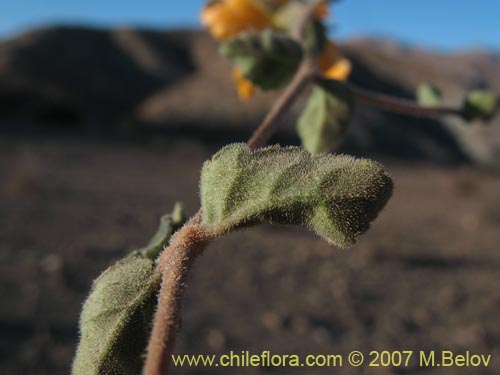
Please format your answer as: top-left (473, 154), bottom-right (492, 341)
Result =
top-left (143, 220), bottom-right (212, 375)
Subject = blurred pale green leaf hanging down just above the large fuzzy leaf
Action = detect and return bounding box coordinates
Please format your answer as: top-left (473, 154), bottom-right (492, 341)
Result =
top-left (297, 80), bottom-right (354, 154)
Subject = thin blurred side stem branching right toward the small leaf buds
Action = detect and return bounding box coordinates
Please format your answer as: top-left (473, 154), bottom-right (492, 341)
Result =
top-left (349, 84), bottom-right (463, 117)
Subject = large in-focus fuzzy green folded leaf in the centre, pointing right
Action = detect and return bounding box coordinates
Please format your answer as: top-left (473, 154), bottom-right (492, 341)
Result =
top-left (200, 144), bottom-right (392, 247)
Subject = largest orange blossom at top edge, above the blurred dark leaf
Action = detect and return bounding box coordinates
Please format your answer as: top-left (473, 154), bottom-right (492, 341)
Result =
top-left (200, 0), bottom-right (271, 40)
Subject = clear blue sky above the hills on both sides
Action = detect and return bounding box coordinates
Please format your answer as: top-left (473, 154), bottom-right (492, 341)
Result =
top-left (0, 0), bottom-right (500, 51)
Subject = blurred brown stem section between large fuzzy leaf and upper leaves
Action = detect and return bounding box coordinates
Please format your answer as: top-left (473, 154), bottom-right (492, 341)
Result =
top-left (247, 59), bottom-right (315, 149)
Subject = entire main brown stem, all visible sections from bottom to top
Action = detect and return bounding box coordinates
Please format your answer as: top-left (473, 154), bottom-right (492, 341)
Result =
top-left (143, 5), bottom-right (322, 375)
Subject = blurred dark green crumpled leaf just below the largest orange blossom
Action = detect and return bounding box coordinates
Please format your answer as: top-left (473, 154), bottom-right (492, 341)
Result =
top-left (220, 29), bottom-right (302, 90)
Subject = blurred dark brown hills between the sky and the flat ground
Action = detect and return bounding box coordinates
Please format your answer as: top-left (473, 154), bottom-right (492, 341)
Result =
top-left (0, 27), bottom-right (500, 164)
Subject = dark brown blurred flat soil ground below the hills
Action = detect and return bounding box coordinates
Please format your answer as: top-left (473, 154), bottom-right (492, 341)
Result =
top-left (0, 136), bottom-right (500, 375)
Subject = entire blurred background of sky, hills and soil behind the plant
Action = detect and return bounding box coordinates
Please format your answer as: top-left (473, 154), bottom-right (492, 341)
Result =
top-left (0, 0), bottom-right (500, 375)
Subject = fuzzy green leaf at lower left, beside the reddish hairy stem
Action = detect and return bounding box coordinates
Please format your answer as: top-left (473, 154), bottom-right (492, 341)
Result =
top-left (72, 205), bottom-right (185, 375)
